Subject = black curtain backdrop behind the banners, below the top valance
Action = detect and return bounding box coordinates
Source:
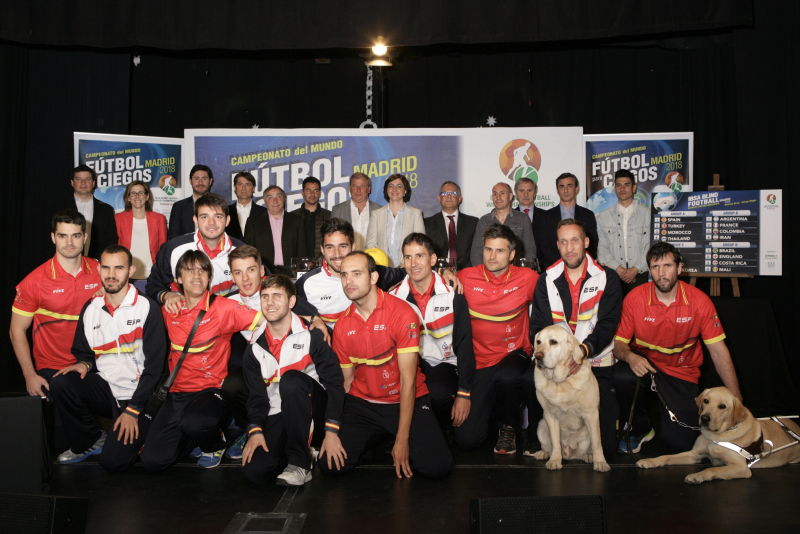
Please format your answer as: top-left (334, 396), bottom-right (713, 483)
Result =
top-left (0, 0), bottom-right (800, 409)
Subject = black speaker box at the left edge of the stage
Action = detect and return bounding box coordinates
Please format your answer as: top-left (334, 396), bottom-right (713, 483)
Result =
top-left (0, 396), bottom-right (50, 494)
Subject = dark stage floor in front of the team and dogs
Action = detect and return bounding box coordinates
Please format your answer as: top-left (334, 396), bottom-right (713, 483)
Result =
top-left (50, 442), bottom-right (800, 534)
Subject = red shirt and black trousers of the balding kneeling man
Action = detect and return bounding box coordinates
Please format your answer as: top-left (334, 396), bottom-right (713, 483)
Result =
top-left (318, 289), bottom-right (453, 478)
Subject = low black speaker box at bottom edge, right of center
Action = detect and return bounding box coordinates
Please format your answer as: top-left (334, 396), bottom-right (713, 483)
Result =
top-left (469, 495), bottom-right (606, 534)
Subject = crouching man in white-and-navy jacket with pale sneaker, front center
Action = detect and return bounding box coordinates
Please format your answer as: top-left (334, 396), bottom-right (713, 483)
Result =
top-left (242, 274), bottom-right (344, 486)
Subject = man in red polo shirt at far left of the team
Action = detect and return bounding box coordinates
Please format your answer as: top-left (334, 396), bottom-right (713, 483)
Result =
top-left (11, 210), bottom-right (100, 397)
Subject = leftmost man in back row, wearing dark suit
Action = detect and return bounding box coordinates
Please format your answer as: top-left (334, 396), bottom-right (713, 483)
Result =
top-left (56, 165), bottom-right (119, 261)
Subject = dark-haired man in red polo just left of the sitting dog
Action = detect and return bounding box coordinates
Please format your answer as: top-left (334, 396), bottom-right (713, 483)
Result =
top-left (455, 224), bottom-right (539, 454)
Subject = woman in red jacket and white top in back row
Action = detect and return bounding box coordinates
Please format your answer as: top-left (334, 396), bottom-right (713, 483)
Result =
top-left (115, 180), bottom-right (167, 280)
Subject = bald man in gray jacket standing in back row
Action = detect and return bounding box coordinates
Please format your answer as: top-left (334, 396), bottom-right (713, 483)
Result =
top-left (470, 182), bottom-right (536, 266)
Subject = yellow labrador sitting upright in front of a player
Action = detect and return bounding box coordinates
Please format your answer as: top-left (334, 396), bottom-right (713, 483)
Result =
top-left (533, 326), bottom-right (611, 471)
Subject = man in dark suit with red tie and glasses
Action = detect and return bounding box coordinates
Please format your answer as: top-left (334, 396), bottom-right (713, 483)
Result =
top-left (424, 181), bottom-right (478, 270)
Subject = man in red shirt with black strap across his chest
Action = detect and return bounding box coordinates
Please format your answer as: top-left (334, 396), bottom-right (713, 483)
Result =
top-left (141, 250), bottom-right (264, 471)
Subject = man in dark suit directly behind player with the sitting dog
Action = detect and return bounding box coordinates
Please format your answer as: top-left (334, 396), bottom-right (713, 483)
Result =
top-left (537, 172), bottom-right (597, 270)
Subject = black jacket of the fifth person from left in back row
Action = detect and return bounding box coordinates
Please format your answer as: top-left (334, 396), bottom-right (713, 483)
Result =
top-left (244, 211), bottom-right (306, 272)
